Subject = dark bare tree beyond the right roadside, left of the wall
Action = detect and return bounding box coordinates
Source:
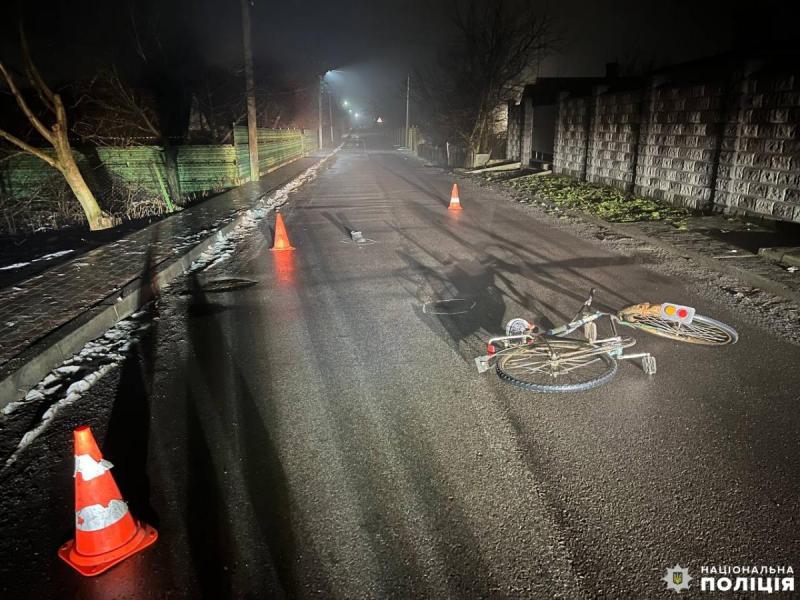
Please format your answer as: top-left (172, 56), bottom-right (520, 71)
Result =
top-left (414, 0), bottom-right (554, 162)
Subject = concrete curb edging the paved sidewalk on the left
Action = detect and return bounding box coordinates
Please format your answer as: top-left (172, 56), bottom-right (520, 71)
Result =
top-left (0, 151), bottom-right (335, 410)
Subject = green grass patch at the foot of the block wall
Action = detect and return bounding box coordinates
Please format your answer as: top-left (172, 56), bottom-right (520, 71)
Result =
top-left (506, 175), bottom-right (692, 229)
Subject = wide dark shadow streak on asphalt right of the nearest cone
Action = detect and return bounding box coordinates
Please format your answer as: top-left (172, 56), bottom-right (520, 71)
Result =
top-left (181, 274), bottom-right (332, 598)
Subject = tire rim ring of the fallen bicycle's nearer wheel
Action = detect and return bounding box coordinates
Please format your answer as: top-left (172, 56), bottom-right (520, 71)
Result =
top-left (495, 336), bottom-right (618, 393)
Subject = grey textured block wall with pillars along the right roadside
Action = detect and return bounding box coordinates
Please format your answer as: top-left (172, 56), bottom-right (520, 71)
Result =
top-left (553, 61), bottom-right (800, 222)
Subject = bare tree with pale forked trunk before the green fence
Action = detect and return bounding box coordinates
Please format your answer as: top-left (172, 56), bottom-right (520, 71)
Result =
top-left (0, 27), bottom-right (114, 230)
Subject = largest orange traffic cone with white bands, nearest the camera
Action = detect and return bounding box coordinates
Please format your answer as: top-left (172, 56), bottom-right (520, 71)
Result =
top-left (58, 425), bottom-right (158, 576)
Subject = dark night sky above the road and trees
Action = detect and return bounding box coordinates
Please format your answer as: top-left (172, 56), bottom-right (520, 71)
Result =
top-left (0, 0), bottom-right (796, 125)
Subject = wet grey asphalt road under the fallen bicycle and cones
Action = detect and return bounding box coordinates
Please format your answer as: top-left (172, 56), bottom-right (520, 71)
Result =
top-left (0, 132), bottom-right (800, 599)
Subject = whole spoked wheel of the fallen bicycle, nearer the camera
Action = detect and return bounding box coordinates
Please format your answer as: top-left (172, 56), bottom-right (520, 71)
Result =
top-left (496, 336), bottom-right (617, 392)
